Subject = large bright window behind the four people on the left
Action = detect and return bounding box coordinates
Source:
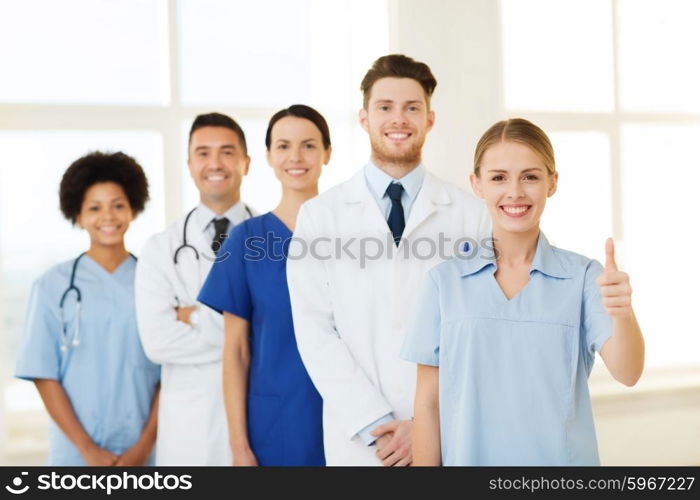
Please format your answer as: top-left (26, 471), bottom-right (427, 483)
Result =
top-left (0, 0), bottom-right (389, 464)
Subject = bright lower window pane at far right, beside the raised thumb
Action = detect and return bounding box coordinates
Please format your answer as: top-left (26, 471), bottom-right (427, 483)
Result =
top-left (622, 124), bottom-right (700, 365)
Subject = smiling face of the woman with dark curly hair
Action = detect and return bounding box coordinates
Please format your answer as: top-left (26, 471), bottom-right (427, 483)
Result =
top-left (76, 182), bottom-right (134, 246)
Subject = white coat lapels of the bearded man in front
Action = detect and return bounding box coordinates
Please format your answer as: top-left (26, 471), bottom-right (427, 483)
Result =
top-left (343, 169), bottom-right (452, 237)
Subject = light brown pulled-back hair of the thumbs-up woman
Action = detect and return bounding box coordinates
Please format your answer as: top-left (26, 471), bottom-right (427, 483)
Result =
top-left (474, 118), bottom-right (556, 177)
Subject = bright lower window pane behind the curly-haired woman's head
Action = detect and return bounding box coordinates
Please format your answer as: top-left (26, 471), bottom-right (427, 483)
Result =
top-left (0, 130), bottom-right (165, 280)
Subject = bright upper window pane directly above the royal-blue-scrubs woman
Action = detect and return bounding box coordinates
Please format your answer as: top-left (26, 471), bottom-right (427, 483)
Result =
top-left (178, 0), bottom-right (388, 112)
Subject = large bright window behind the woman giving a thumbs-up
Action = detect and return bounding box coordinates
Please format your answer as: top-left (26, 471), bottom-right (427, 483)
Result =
top-left (501, 0), bottom-right (700, 366)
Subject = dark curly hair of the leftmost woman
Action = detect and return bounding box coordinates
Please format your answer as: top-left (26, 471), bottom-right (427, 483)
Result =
top-left (59, 151), bottom-right (148, 224)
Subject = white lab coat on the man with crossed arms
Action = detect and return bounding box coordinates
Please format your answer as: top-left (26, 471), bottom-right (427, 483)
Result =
top-left (135, 208), bottom-right (247, 465)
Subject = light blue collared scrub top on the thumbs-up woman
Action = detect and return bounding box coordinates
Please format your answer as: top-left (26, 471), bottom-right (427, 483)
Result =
top-left (401, 233), bottom-right (612, 465)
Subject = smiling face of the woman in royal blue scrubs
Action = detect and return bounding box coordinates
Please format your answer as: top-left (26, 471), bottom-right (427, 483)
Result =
top-left (267, 116), bottom-right (331, 191)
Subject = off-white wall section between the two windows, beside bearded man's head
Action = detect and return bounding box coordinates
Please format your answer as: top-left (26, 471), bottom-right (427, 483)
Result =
top-left (390, 0), bottom-right (503, 187)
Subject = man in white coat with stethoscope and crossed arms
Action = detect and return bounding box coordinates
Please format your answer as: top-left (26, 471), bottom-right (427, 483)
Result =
top-left (135, 113), bottom-right (252, 465)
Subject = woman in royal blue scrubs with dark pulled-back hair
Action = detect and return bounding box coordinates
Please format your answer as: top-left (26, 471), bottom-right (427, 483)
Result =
top-left (198, 104), bottom-right (331, 466)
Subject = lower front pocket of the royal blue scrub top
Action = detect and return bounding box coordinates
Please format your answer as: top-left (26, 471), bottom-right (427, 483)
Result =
top-left (248, 394), bottom-right (284, 465)
